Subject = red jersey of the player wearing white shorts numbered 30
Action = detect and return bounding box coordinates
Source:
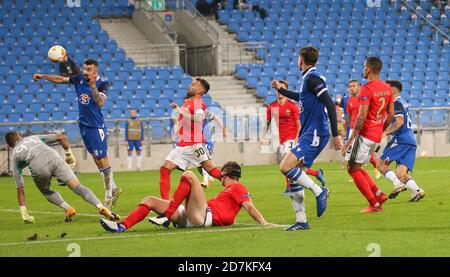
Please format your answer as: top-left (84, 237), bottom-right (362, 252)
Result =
top-left (178, 99), bottom-right (206, 146)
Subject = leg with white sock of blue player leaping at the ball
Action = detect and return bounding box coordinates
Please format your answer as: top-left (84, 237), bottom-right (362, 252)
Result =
top-left (92, 156), bottom-right (122, 209)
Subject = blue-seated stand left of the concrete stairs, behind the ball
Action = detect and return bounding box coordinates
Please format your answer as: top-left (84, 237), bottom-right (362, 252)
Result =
top-left (0, 0), bottom-right (217, 136)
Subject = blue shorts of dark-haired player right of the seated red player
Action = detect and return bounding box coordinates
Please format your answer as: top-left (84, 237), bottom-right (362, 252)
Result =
top-left (291, 135), bottom-right (330, 168)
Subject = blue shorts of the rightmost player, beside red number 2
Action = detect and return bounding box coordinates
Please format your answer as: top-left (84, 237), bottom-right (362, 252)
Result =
top-left (380, 143), bottom-right (417, 172)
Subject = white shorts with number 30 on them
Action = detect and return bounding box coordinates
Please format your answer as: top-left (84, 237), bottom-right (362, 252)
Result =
top-left (166, 143), bottom-right (211, 170)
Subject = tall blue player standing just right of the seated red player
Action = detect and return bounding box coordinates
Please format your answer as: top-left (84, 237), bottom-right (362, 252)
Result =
top-left (272, 46), bottom-right (341, 231)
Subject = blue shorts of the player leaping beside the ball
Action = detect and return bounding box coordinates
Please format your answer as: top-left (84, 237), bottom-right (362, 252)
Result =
top-left (80, 124), bottom-right (108, 159)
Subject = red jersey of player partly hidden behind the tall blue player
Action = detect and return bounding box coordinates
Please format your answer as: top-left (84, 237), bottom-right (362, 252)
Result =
top-left (267, 99), bottom-right (300, 144)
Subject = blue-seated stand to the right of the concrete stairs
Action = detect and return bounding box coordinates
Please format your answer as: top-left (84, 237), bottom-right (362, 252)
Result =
top-left (219, 0), bottom-right (450, 117)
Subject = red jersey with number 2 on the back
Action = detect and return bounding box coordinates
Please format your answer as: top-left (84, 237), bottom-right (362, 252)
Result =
top-left (359, 80), bottom-right (394, 142)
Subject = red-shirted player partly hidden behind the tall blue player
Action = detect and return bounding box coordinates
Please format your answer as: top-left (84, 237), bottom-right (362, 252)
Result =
top-left (267, 80), bottom-right (325, 194)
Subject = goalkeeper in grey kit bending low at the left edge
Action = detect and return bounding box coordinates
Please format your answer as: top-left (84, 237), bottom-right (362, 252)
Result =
top-left (5, 132), bottom-right (119, 223)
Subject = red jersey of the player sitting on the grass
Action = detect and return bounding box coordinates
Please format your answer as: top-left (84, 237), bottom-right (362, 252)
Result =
top-left (208, 183), bottom-right (252, 226)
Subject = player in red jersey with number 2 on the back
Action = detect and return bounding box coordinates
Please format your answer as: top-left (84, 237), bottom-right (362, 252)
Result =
top-left (342, 57), bottom-right (394, 212)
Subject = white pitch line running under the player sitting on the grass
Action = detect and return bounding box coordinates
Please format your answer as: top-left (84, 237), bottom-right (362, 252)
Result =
top-left (0, 225), bottom-right (284, 247)
